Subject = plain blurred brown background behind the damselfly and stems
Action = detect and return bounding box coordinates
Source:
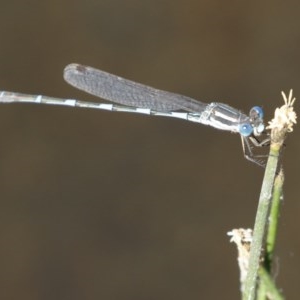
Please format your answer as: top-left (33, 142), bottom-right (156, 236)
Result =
top-left (0, 0), bottom-right (300, 300)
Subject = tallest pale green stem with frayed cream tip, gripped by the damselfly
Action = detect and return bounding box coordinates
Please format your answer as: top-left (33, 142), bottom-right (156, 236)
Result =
top-left (243, 90), bottom-right (297, 300)
